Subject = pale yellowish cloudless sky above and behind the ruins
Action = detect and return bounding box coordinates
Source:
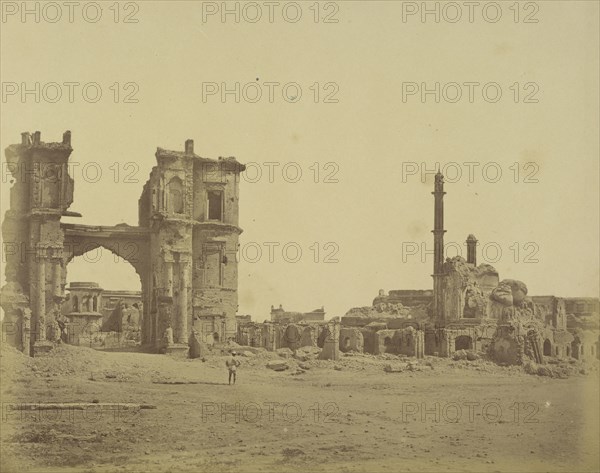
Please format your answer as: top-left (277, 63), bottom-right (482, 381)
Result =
top-left (0, 1), bottom-right (600, 321)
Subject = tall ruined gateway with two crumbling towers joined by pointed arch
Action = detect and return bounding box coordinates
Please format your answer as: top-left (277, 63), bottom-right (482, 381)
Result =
top-left (0, 131), bottom-right (245, 355)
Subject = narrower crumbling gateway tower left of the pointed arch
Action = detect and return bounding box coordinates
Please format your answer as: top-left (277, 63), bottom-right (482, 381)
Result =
top-left (1, 131), bottom-right (79, 355)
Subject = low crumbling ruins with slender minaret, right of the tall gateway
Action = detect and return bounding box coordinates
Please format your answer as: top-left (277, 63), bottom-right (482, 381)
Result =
top-left (238, 172), bottom-right (599, 364)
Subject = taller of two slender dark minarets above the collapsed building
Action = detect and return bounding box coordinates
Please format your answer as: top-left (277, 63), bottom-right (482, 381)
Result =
top-left (432, 170), bottom-right (446, 323)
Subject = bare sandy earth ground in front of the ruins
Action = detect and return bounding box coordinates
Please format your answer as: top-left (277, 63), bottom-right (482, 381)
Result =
top-left (1, 346), bottom-right (599, 473)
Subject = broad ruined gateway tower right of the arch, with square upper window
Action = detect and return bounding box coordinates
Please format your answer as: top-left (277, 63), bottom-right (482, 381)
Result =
top-left (139, 140), bottom-right (245, 351)
